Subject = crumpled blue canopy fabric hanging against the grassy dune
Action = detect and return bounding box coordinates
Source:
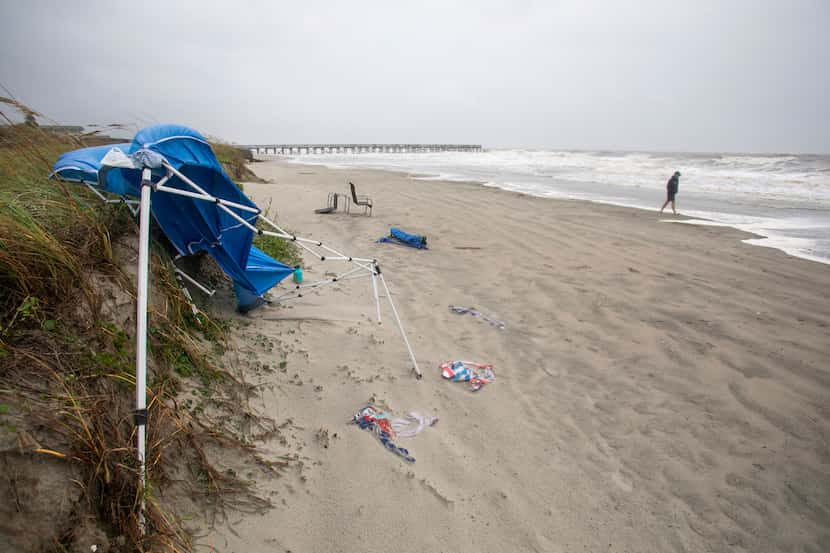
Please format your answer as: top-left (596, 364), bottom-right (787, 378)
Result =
top-left (53, 125), bottom-right (293, 311)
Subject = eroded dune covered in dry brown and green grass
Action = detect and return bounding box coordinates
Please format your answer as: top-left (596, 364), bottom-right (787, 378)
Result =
top-left (0, 104), bottom-right (280, 551)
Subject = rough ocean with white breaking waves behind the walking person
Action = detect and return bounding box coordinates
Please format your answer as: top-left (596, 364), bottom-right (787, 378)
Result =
top-left (292, 149), bottom-right (830, 264)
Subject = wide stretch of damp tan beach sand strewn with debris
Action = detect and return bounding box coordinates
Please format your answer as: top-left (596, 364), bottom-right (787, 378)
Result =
top-left (200, 161), bottom-right (830, 553)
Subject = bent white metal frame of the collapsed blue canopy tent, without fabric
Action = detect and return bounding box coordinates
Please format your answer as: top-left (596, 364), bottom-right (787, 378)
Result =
top-left (130, 159), bottom-right (422, 533)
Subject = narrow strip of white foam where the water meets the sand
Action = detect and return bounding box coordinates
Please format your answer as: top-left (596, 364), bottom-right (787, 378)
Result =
top-left (274, 154), bottom-right (830, 265)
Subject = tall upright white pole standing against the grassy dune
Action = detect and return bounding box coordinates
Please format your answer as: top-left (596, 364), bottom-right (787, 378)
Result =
top-left (135, 168), bottom-right (152, 535)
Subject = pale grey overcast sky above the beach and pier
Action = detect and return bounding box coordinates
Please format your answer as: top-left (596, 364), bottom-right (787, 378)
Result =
top-left (0, 0), bottom-right (830, 153)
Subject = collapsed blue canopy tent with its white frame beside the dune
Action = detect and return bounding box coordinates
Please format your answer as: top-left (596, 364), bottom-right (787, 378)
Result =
top-left (52, 125), bottom-right (422, 532)
